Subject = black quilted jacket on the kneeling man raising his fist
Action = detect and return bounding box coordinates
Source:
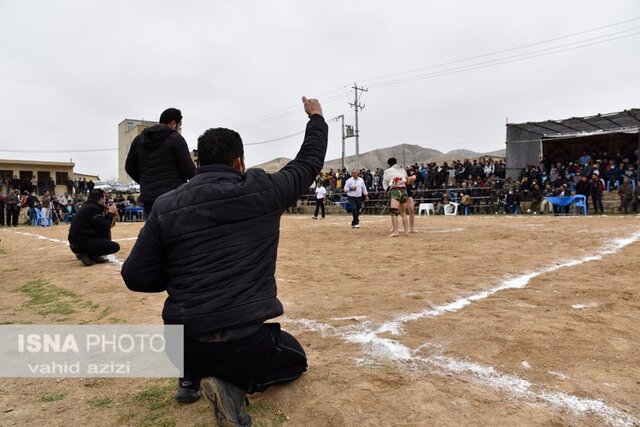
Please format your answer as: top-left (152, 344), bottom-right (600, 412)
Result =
top-left (122, 115), bottom-right (327, 337)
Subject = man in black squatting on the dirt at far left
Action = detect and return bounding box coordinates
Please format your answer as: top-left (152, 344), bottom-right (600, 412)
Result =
top-left (68, 189), bottom-right (120, 265)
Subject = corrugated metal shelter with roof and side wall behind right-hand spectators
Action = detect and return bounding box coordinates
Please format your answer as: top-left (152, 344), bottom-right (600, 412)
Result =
top-left (507, 108), bottom-right (640, 177)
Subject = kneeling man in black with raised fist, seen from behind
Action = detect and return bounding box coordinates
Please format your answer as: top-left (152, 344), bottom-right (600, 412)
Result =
top-left (122, 98), bottom-right (327, 425)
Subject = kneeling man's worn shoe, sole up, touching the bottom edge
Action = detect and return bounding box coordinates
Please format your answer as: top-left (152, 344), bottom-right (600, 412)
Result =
top-left (200, 377), bottom-right (252, 426)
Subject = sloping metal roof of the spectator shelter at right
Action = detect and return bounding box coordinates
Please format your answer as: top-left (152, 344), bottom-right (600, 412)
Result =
top-left (507, 108), bottom-right (640, 138)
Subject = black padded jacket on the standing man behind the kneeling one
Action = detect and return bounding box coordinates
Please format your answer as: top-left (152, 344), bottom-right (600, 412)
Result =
top-left (125, 124), bottom-right (196, 202)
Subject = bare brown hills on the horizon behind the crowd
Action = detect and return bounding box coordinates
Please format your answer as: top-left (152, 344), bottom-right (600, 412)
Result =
top-left (254, 144), bottom-right (506, 172)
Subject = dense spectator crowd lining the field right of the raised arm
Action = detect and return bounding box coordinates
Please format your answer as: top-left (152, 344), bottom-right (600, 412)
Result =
top-left (310, 150), bottom-right (640, 214)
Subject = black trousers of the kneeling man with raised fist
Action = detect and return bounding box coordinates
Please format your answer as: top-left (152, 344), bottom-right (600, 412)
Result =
top-left (184, 323), bottom-right (307, 393)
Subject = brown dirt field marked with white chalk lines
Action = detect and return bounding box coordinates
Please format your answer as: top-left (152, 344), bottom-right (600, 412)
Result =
top-left (0, 215), bottom-right (640, 426)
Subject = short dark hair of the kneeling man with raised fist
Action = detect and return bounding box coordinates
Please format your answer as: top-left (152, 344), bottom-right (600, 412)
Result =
top-left (198, 128), bottom-right (244, 166)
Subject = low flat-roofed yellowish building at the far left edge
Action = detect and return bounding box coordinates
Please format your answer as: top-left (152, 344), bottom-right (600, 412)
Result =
top-left (0, 160), bottom-right (75, 194)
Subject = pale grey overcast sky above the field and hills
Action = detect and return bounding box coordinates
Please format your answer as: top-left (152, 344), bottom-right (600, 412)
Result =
top-left (0, 0), bottom-right (640, 179)
